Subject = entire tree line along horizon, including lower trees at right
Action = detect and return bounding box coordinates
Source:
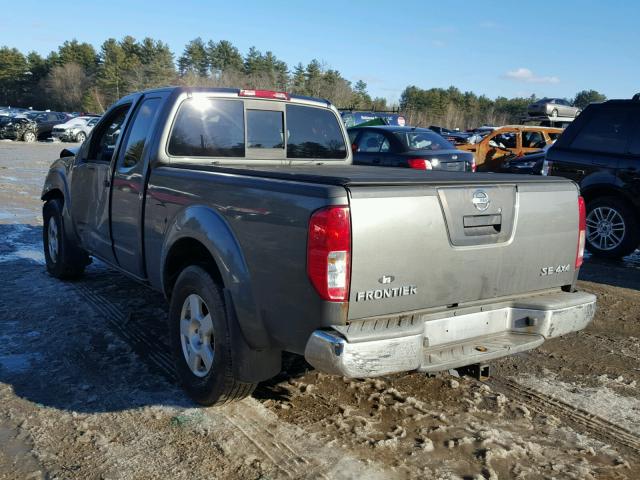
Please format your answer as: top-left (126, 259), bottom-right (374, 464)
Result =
top-left (0, 36), bottom-right (605, 128)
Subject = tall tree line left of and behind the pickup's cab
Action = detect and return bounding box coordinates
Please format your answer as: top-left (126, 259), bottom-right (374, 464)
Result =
top-left (0, 36), bottom-right (387, 112)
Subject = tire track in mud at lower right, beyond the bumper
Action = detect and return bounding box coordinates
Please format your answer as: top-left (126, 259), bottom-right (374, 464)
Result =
top-left (487, 377), bottom-right (640, 457)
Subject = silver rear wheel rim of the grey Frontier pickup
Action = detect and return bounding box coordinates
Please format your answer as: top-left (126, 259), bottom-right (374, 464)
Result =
top-left (180, 293), bottom-right (214, 377)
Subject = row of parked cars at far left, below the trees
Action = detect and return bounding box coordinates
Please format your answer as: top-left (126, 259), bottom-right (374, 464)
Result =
top-left (0, 108), bottom-right (100, 143)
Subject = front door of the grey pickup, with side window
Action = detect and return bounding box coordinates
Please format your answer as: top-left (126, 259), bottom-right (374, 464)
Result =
top-left (71, 103), bottom-right (131, 263)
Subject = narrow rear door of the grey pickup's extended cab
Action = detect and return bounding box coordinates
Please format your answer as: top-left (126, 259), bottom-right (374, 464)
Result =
top-left (111, 96), bottom-right (162, 278)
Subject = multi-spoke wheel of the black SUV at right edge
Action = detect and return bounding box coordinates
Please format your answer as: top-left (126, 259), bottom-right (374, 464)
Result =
top-left (586, 197), bottom-right (640, 258)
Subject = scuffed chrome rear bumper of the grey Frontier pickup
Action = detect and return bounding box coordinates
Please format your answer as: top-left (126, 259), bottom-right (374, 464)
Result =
top-left (304, 292), bottom-right (596, 378)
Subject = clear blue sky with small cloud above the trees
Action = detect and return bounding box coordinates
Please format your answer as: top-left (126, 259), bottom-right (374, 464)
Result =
top-left (0, 0), bottom-right (640, 101)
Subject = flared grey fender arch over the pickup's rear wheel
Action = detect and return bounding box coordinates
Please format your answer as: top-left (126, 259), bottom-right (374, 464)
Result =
top-left (160, 205), bottom-right (270, 349)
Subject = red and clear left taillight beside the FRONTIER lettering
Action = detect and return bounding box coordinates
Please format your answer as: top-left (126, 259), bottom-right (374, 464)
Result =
top-left (307, 206), bottom-right (351, 302)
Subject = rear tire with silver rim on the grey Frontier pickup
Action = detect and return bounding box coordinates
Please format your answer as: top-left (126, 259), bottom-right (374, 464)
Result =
top-left (169, 266), bottom-right (255, 405)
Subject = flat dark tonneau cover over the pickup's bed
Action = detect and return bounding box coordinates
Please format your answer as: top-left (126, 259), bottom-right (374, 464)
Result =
top-left (171, 164), bottom-right (568, 187)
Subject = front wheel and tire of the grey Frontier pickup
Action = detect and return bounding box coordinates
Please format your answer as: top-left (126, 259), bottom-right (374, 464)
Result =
top-left (42, 199), bottom-right (89, 279)
